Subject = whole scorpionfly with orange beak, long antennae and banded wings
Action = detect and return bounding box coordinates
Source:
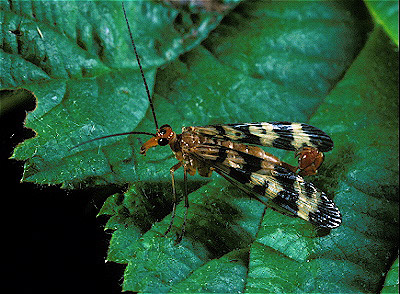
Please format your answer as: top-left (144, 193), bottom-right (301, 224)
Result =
top-left (73, 4), bottom-right (341, 242)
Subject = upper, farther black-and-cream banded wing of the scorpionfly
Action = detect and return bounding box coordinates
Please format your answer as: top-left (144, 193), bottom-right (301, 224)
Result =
top-left (191, 122), bottom-right (333, 152)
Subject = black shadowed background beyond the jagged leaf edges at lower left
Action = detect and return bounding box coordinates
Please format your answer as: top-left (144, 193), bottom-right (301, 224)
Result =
top-left (0, 93), bottom-right (125, 293)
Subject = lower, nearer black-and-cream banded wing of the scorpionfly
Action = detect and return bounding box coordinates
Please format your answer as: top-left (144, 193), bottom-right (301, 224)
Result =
top-left (191, 144), bottom-right (341, 228)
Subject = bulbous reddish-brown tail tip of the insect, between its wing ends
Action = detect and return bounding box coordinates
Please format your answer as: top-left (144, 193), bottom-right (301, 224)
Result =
top-left (295, 146), bottom-right (324, 176)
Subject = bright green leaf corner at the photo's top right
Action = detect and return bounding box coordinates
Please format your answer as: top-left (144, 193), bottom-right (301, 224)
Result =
top-left (365, 0), bottom-right (399, 46)
